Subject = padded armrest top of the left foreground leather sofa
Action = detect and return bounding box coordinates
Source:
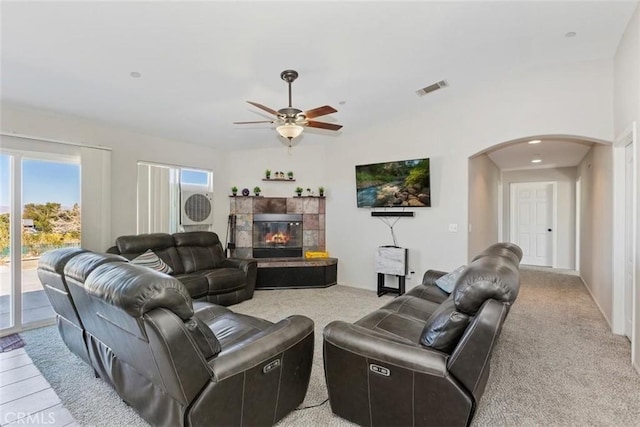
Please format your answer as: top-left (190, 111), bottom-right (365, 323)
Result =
top-left (209, 315), bottom-right (314, 381)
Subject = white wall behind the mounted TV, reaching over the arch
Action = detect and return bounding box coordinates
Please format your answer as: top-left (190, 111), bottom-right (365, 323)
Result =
top-left (229, 60), bottom-right (613, 289)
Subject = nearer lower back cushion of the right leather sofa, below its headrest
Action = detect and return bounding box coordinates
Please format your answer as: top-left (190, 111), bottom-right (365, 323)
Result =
top-left (420, 297), bottom-right (469, 354)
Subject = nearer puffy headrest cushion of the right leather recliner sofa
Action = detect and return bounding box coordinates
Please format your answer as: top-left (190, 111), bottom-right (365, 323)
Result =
top-left (452, 255), bottom-right (520, 315)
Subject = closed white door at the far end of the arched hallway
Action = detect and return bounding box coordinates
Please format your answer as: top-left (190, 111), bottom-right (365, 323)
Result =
top-left (510, 182), bottom-right (554, 267)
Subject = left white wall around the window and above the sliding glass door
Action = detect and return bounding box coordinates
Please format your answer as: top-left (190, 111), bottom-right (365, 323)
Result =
top-left (2, 104), bottom-right (229, 249)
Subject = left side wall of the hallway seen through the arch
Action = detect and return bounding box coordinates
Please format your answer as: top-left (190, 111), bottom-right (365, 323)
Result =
top-left (463, 154), bottom-right (500, 259)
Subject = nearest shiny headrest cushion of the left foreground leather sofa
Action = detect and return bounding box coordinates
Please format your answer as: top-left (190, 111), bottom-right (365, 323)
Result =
top-left (84, 263), bottom-right (193, 320)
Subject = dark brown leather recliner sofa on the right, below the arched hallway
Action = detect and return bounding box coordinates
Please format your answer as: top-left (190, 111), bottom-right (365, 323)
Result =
top-left (323, 243), bottom-right (522, 426)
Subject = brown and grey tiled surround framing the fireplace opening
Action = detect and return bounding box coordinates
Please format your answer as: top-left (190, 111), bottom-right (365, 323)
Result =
top-left (229, 196), bottom-right (325, 258)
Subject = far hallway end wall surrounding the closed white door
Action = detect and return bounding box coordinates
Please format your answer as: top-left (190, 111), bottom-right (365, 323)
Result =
top-left (502, 167), bottom-right (576, 269)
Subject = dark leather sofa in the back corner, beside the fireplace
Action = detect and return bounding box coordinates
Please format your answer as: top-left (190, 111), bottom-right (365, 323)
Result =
top-left (107, 231), bottom-right (258, 306)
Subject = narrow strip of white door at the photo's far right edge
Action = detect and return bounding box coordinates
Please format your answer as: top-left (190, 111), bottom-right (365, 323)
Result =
top-left (624, 144), bottom-right (634, 339)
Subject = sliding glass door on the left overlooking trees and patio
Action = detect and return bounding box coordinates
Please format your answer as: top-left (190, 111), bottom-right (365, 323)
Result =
top-left (0, 151), bottom-right (81, 335)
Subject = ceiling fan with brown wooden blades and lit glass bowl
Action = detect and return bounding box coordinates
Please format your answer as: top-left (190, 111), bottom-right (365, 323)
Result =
top-left (233, 70), bottom-right (342, 147)
